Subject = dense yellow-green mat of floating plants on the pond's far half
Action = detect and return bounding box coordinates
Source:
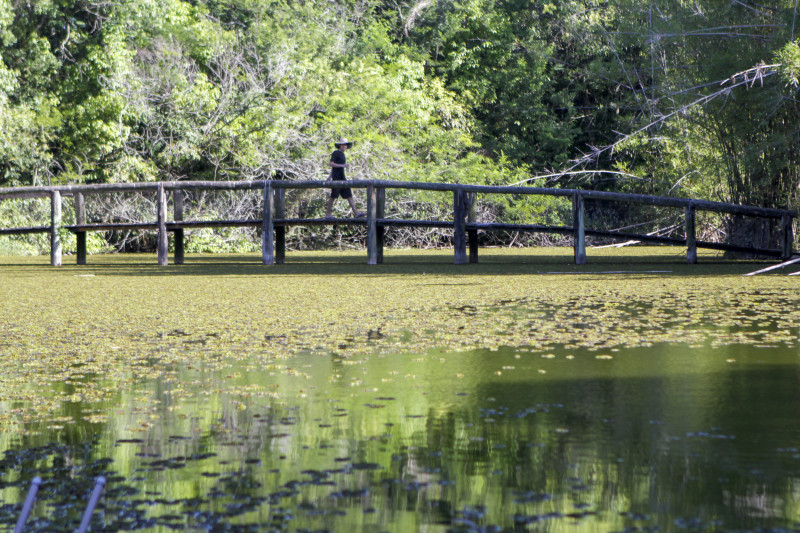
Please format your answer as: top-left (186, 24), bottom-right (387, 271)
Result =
top-left (0, 248), bottom-right (800, 432)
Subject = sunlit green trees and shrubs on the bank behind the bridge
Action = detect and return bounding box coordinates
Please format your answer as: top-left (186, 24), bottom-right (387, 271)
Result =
top-left (0, 0), bottom-right (800, 253)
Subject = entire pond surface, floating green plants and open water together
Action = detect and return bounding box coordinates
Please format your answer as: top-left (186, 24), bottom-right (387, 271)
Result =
top-left (0, 248), bottom-right (800, 531)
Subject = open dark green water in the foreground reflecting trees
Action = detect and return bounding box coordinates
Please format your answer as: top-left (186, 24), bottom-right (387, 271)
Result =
top-left (0, 345), bottom-right (800, 532)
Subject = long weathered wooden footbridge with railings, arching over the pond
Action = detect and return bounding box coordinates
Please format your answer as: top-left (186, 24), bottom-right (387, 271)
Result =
top-left (0, 180), bottom-right (797, 266)
